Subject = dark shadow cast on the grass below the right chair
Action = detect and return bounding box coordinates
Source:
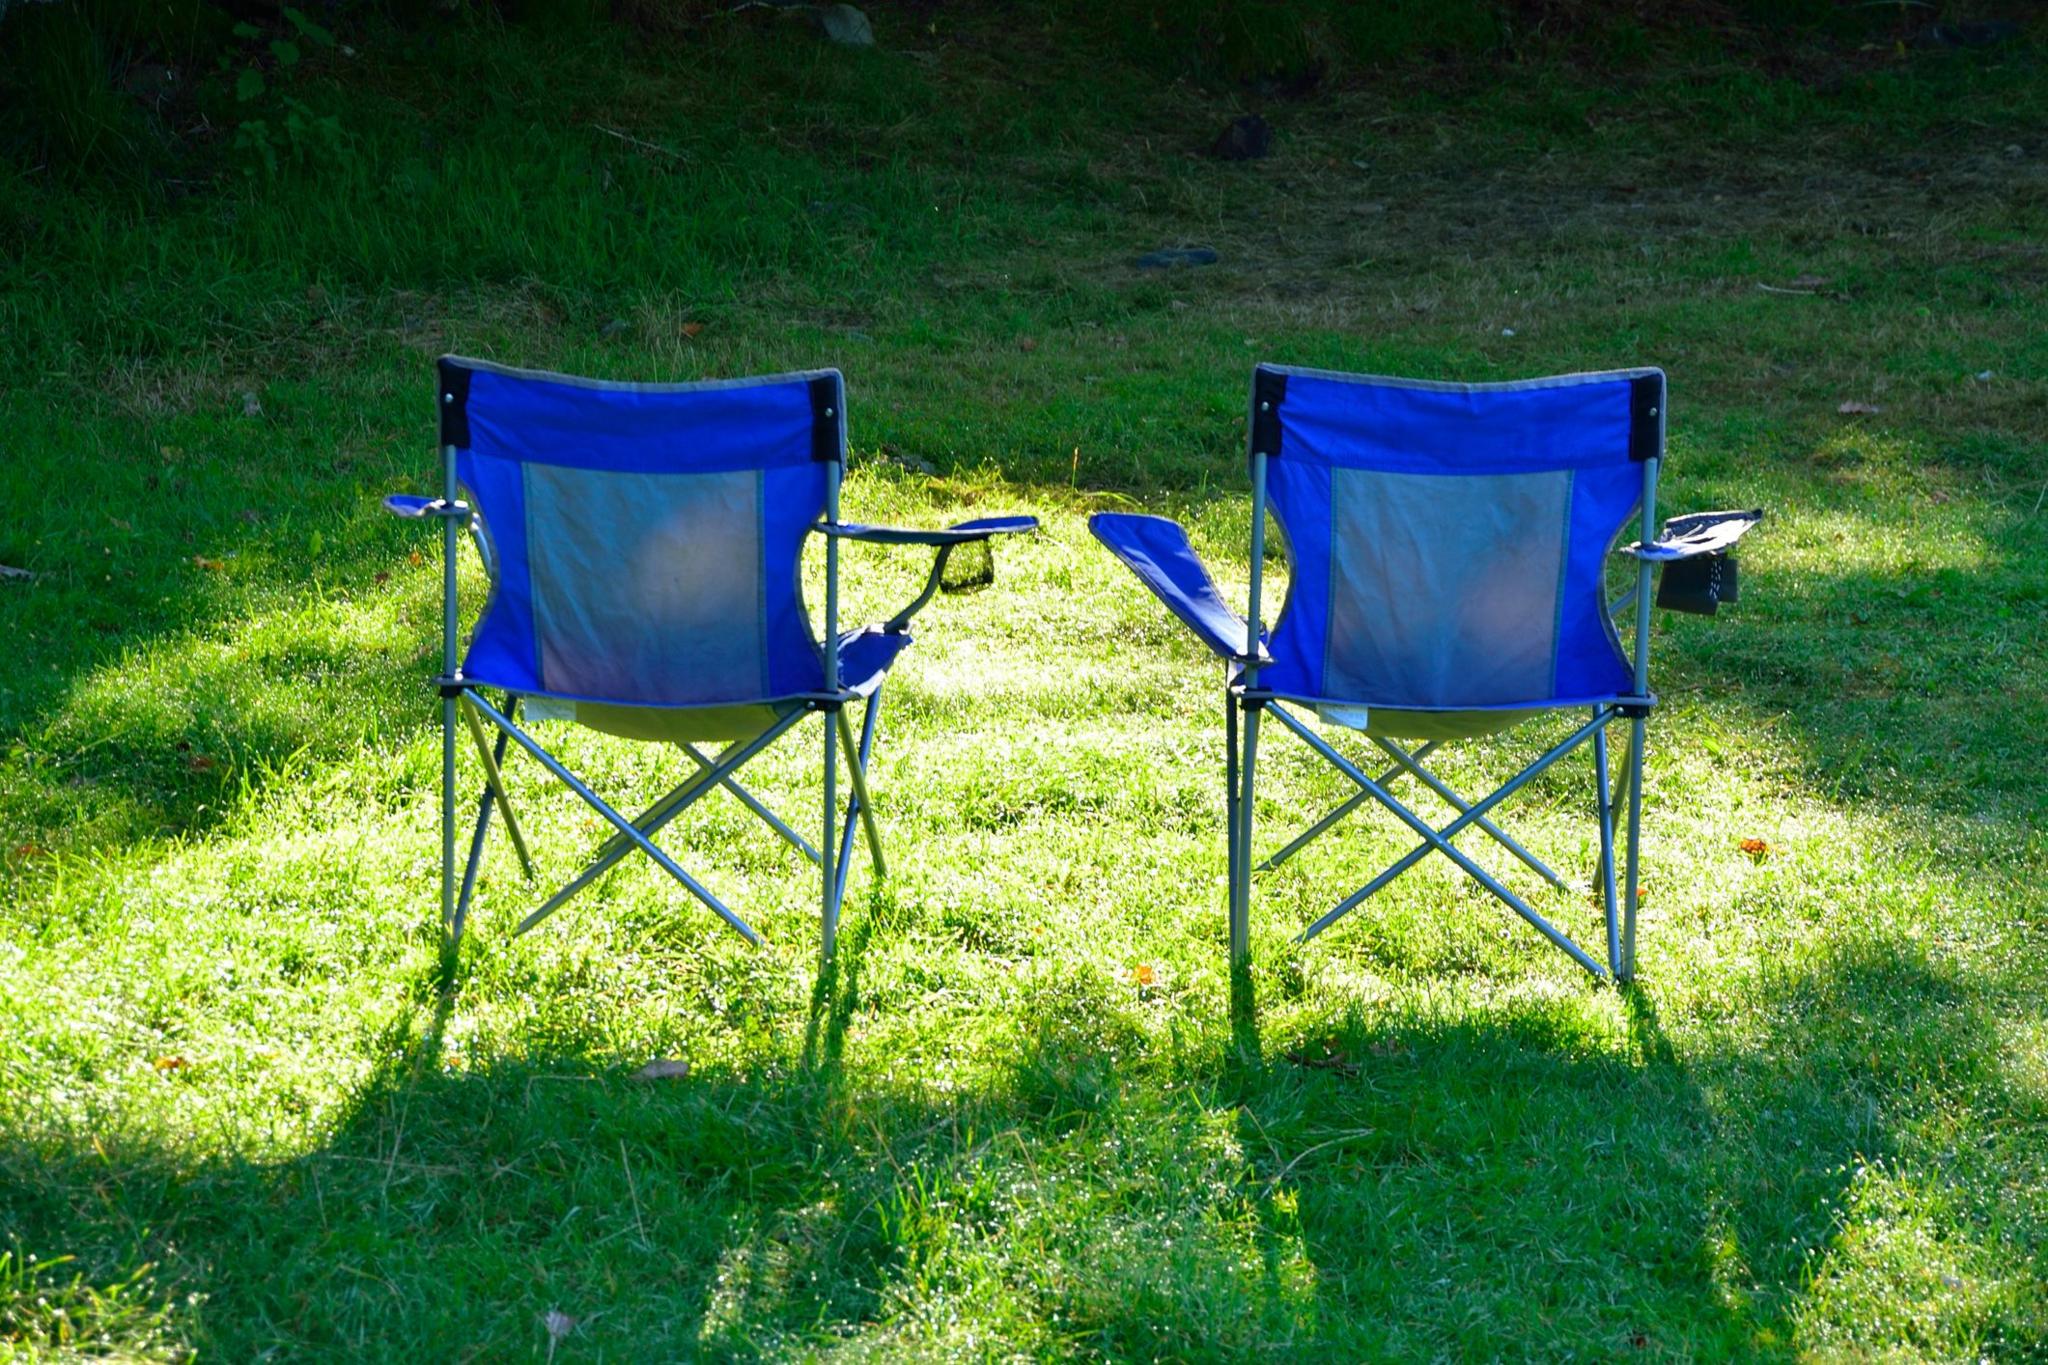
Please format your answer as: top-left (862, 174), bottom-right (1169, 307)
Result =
top-left (1212, 941), bottom-right (2042, 1359)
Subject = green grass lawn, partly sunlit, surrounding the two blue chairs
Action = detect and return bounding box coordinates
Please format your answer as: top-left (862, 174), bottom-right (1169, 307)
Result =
top-left (0, 8), bottom-right (2048, 1361)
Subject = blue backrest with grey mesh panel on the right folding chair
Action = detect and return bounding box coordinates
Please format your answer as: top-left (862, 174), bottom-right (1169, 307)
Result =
top-left (1251, 366), bottom-right (1665, 710)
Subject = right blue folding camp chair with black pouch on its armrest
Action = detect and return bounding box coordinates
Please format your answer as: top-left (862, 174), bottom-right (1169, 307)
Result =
top-left (1090, 364), bottom-right (1761, 980)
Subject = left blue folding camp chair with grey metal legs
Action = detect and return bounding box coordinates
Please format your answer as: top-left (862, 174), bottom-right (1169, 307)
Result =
top-left (385, 356), bottom-right (1036, 958)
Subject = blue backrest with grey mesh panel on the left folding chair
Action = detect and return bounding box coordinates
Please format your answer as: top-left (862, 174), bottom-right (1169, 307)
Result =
top-left (438, 356), bottom-right (846, 706)
